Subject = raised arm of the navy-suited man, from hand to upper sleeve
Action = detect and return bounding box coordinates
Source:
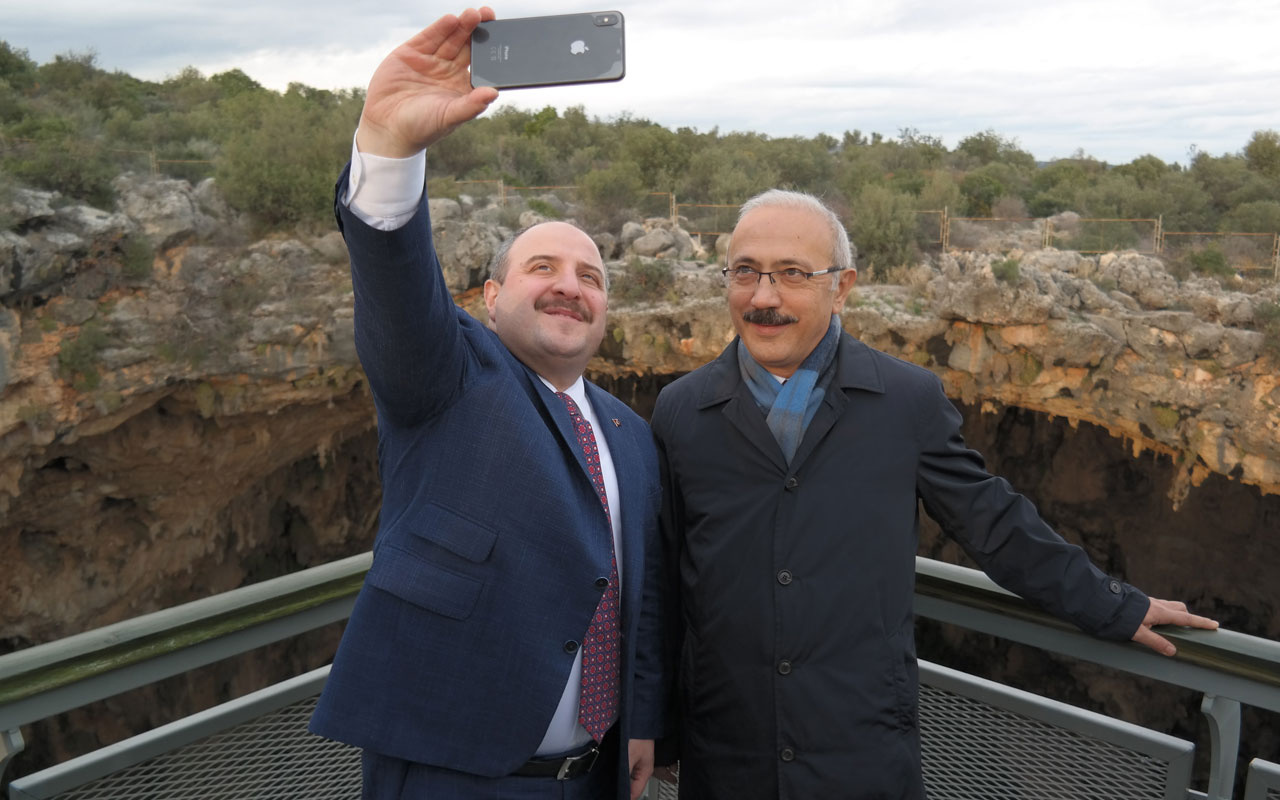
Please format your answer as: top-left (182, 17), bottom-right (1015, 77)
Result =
top-left (338, 8), bottom-right (498, 425)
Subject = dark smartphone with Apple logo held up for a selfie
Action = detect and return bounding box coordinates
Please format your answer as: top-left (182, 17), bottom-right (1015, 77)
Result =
top-left (471, 12), bottom-right (626, 88)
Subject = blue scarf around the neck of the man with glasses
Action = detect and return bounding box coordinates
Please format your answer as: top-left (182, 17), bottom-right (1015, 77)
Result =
top-left (737, 314), bottom-right (841, 465)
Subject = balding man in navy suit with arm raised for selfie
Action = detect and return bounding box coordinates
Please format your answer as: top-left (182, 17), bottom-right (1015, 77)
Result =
top-left (311, 8), bottom-right (663, 800)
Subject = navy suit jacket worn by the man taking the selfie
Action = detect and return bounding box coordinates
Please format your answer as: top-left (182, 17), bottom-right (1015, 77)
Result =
top-left (311, 162), bottom-right (662, 781)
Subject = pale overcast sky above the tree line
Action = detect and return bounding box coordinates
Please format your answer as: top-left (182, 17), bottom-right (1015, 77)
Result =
top-left (0, 0), bottom-right (1280, 164)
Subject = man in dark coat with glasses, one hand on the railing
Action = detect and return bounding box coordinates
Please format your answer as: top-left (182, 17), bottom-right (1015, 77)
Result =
top-left (653, 191), bottom-right (1216, 800)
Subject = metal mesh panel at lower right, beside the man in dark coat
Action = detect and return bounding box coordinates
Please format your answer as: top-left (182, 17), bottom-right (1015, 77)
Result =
top-left (920, 686), bottom-right (1169, 800)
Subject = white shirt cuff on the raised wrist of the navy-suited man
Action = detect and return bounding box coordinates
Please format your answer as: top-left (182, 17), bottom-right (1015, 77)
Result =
top-left (343, 130), bottom-right (426, 230)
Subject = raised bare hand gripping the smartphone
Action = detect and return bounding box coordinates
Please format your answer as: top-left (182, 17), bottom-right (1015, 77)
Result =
top-left (356, 6), bottom-right (498, 159)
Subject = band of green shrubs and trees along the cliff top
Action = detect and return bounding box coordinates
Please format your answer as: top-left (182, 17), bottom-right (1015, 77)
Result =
top-left (0, 42), bottom-right (1280, 266)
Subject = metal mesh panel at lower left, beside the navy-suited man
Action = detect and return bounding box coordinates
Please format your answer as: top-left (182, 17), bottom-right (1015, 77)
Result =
top-left (49, 698), bottom-right (360, 800)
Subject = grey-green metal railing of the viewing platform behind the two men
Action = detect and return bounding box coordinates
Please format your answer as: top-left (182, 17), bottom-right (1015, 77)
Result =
top-left (0, 553), bottom-right (1280, 800)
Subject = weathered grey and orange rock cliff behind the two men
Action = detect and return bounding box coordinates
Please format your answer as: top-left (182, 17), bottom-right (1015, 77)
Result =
top-left (0, 171), bottom-right (1280, 648)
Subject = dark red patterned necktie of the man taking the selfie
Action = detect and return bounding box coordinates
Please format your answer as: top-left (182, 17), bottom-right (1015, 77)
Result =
top-left (556, 392), bottom-right (621, 741)
